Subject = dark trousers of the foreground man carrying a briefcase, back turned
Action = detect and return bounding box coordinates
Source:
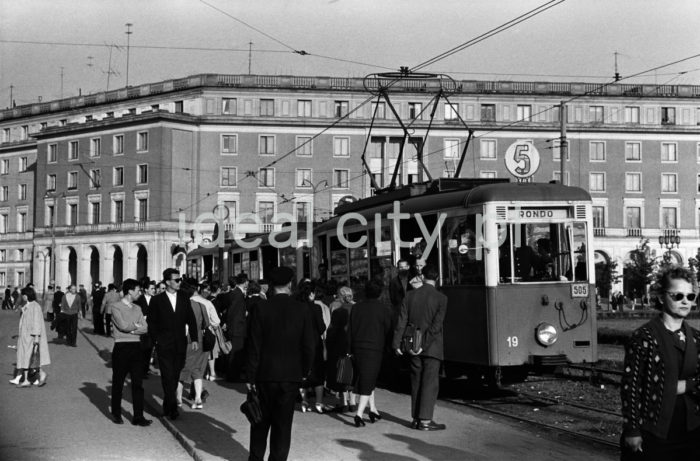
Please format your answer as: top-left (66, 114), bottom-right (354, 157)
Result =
top-left (248, 382), bottom-right (300, 461)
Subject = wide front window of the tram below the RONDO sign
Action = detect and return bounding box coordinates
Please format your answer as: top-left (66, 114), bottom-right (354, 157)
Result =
top-left (498, 223), bottom-right (587, 283)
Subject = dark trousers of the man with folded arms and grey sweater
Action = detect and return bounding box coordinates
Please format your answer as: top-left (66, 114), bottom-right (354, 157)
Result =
top-left (112, 342), bottom-right (143, 419)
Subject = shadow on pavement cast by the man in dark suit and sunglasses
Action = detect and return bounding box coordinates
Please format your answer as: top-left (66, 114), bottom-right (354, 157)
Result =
top-left (168, 411), bottom-right (248, 459)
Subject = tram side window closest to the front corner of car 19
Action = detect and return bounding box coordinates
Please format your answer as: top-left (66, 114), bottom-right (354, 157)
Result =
top-left (442, 215), bottom-right (484, 285)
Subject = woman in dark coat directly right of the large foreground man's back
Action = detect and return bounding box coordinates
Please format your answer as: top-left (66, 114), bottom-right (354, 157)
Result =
top-left (297, 281), bottom-right (326, 413)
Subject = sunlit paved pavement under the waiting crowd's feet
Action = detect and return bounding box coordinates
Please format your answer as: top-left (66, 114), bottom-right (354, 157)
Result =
top-left (0, 311), bottom-right (617, 461)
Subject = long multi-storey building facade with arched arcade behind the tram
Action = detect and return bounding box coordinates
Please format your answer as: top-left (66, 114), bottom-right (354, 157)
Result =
top-left (0, 74), bottom-right (700, 290)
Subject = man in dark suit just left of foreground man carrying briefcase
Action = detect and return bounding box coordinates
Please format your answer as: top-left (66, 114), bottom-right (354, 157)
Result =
top-left (224, 273), bottom-right (248, 382)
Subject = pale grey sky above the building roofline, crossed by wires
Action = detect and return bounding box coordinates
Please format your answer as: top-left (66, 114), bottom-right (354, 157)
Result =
top-left (0, 0), bottom-right (700, 108)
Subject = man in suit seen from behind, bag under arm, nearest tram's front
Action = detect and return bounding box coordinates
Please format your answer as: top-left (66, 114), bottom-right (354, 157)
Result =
top-left (392, 266), bottom-right (447, 431)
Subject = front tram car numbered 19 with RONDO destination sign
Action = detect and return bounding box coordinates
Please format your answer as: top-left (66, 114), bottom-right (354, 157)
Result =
top-left (314, 178), bottom-right (597, 381)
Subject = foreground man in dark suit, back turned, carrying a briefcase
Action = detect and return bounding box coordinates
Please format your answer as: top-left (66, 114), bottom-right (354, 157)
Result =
top-left (246, 267), bottom-right (316, 461)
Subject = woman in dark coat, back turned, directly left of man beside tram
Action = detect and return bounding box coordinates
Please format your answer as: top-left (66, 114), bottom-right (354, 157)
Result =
top-left (348, 279), bottom-right (391, 427)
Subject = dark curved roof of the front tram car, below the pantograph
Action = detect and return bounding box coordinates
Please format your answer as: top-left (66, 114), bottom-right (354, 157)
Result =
top-left (315, 182), bottom-right (591, 232)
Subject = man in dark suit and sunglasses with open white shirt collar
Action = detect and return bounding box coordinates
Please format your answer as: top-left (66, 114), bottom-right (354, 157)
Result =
top-left (147, 268), bottom-right (199, 420)
